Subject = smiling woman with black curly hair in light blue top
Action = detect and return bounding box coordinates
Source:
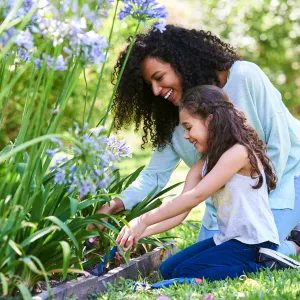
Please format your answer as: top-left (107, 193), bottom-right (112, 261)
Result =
top-left (94, 25), bottom-right (300, 254)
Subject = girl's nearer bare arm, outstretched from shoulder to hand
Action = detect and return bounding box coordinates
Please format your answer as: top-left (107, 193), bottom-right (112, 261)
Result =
top-left (117, 144), bottom-right (248, 249)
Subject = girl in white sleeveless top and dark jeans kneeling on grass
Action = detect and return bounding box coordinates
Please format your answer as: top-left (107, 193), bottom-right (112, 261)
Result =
top-left (117, 85), bottom-right (279, 280)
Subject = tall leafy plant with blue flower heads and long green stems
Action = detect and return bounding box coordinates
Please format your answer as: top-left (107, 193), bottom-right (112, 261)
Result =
top-left (0, 0), bottom-right (166, 299)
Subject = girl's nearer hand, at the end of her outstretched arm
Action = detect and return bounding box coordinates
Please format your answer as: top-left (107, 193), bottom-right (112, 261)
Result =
top-left (117, 217), bottom-right (147, 252)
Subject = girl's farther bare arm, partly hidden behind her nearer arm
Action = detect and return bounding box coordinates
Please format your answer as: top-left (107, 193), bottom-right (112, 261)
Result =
top-left (140, 159), bottom-right (204, 238)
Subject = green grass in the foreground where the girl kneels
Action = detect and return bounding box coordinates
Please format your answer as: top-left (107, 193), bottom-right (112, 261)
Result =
top-left (91, 216), bottom-right (300, 300)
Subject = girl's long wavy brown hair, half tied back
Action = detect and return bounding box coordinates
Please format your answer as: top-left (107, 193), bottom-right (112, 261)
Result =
top-left (179, 85), bottom-right (277, 192)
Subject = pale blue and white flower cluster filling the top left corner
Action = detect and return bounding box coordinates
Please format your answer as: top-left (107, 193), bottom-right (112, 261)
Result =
top-left (0, 0), bottom-right (113, 70)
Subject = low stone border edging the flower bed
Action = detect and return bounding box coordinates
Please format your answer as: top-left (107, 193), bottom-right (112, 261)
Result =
top-left (32, 242), bottom-right (176, 300)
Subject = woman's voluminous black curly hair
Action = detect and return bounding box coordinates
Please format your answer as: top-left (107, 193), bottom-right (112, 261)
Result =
top-left (112, 25), bottom-right (240, 149)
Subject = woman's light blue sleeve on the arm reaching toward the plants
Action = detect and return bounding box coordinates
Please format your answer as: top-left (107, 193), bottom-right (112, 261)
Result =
top-left (119, 145), bottom-right (180, 210)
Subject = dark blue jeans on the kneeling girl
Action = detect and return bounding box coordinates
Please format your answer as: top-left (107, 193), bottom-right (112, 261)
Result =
top-left (159, 238), bottom-right (278, 281)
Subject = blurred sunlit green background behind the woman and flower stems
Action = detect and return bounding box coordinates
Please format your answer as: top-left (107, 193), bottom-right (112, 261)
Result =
top-left (0, 0), bottom-right (300, 190)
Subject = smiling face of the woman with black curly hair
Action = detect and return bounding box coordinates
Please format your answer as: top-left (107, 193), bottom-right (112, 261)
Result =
top-left (141, 57), bottom-right (182, 106)
